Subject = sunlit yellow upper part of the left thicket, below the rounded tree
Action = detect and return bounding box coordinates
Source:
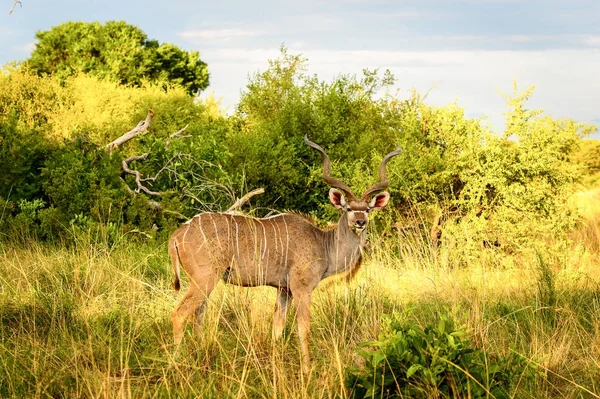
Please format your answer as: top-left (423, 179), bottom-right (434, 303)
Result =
top-left (0, 68), bottom-right (203, 145)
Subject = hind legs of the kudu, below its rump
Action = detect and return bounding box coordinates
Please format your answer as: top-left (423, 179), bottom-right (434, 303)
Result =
top-left (171, 265), bottom-right (220, 345)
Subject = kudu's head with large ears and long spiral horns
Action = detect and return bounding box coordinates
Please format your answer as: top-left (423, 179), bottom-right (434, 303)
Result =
top-left (304, 136), bottom-right (401, 235)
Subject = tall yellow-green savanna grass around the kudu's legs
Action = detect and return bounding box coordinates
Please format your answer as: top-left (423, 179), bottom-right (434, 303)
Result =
top-left (0, 191), bottom-right (600, 398)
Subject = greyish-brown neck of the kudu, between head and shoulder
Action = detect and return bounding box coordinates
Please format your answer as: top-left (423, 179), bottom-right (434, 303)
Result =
top-left (323, 212), bottom-right (367, 278)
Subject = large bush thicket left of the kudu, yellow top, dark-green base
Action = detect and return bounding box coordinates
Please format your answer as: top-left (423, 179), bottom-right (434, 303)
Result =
top-left (0, 65), bottom-right (233, 241)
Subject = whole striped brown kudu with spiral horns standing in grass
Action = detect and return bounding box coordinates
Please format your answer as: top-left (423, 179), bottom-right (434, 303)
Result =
top-left (169, 136), bottom-right (401, 373)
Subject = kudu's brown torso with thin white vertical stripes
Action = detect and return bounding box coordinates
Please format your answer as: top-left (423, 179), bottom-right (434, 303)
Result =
top-left (169, 213), bottom-right (326, 288)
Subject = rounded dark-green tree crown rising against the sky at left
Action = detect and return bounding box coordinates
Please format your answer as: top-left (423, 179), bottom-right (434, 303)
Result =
top-left (26, 21), bottom-right (208, 94)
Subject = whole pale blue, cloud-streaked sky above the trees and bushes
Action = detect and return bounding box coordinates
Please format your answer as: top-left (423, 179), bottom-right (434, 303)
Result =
top-left (0, 0), bottom-right (600, 137)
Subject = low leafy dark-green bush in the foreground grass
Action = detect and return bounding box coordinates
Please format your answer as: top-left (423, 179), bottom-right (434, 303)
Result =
top-left (345, 315), bottom-right (535, 398)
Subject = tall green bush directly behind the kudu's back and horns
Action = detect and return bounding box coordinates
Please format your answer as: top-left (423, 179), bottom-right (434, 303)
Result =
top-left (227, 48), bottom-right (404, 213)
